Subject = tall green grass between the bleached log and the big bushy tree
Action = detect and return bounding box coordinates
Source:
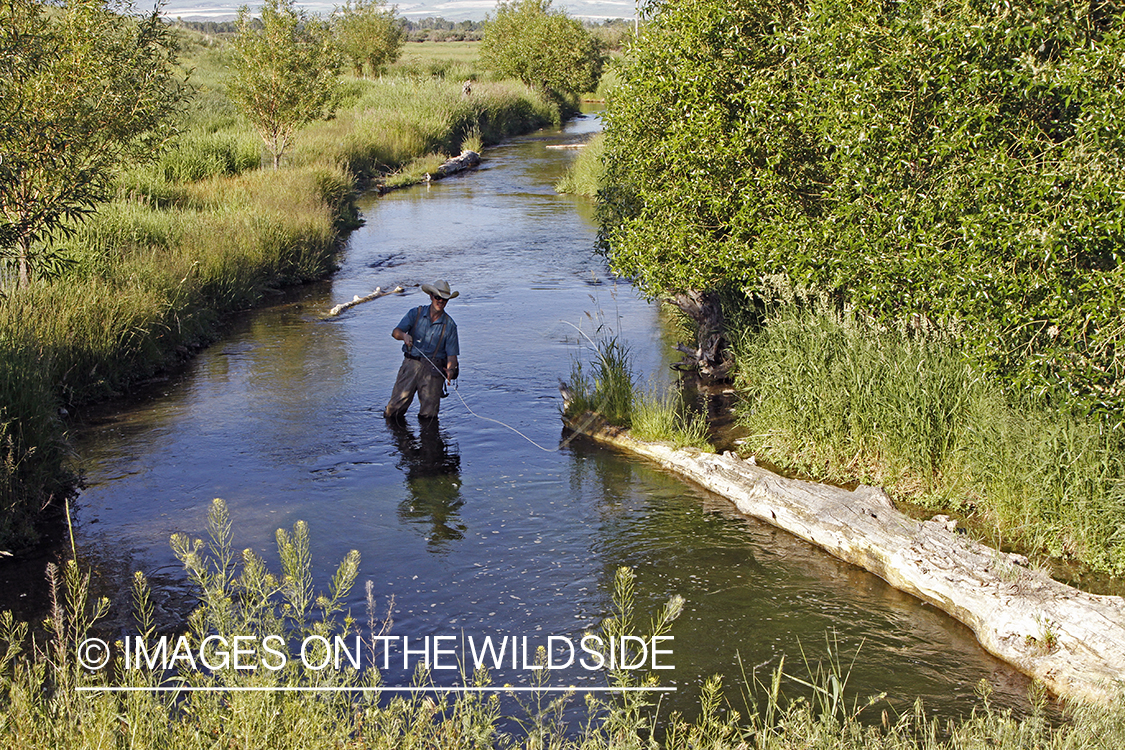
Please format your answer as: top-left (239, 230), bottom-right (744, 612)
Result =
top-left (734, 305), bottom-right (1125, 575)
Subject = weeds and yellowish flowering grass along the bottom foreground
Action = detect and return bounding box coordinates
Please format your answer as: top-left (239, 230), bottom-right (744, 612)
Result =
top-left (0, 500), bottom-right (1125, 750)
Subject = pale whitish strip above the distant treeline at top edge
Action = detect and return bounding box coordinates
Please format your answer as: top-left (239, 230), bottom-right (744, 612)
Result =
top-left (158, 0), bottom-right (637, 21)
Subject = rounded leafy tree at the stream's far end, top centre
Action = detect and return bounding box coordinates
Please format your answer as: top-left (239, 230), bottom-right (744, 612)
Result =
top-left (480, 0), bottom-right (604, 97)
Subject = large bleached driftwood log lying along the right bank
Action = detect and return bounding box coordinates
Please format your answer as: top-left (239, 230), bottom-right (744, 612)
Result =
top-left (565, 415), bottom-right (1125, 702)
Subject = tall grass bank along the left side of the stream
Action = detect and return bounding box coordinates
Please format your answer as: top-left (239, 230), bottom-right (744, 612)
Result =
top-left (0, 27), bottom-right (561, 550)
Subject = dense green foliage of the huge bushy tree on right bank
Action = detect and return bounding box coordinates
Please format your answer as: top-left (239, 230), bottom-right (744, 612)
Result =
top-left (600, 0), bottom-right (1125, 414)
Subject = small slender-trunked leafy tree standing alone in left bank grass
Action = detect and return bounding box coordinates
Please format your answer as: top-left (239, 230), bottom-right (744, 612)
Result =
top-left (227, 0), bottom-right (339, 169)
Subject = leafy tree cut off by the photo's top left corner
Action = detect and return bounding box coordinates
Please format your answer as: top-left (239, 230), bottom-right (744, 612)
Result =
top-left (0, 0), bottom-right (185, 288)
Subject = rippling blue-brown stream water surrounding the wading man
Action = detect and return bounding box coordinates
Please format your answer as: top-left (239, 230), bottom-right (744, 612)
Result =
top-left (70, 118), bottom-right (1026, 716)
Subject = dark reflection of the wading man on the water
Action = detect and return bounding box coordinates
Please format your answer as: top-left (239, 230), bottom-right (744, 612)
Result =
top-left (387, 419), bottom-right (466, 552)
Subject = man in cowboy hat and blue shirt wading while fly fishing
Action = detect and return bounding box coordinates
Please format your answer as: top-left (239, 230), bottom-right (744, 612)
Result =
top-left (383, 279), bottom-right (460, 419)
